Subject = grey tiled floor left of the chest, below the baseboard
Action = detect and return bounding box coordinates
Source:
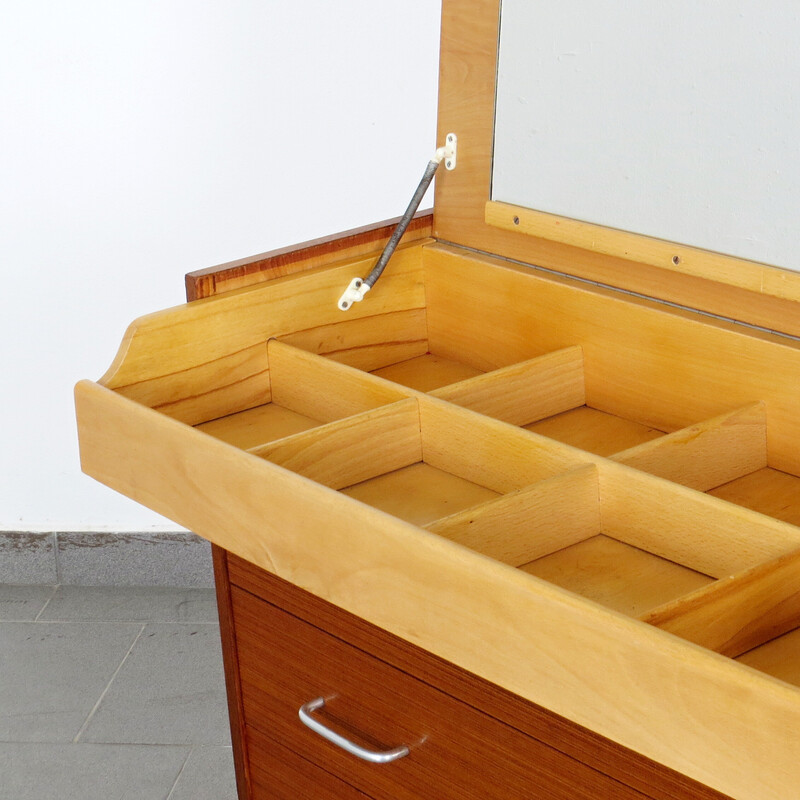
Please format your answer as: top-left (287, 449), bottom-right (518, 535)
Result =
top-left (0, 584), bottom-right (236, 800)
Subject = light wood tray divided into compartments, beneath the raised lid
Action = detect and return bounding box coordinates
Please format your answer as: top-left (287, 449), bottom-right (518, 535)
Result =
top-left (76, 238), bottom-right (800, 800)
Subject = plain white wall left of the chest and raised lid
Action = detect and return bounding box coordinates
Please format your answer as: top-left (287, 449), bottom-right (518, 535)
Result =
top-left (0, 6), bottom-right (440, 531)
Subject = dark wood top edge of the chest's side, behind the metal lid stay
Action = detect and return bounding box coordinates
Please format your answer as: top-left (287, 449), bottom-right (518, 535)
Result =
top-left (186, 210), bottom-right (433, 301)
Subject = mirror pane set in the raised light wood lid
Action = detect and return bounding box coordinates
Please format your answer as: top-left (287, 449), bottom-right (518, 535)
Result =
top-left (492, 0), bottom-right (800, 271)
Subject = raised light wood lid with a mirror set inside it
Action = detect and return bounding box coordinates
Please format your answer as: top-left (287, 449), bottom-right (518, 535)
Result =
top-left (434, 0), bottom-right (800, 336)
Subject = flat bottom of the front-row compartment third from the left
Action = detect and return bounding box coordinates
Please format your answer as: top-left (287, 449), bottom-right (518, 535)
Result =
top-left (521, 535), bottom-right (713, 617)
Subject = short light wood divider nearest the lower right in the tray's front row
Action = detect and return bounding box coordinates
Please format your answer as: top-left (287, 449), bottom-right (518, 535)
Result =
top-left (642, 550), bottom-right (800, 656)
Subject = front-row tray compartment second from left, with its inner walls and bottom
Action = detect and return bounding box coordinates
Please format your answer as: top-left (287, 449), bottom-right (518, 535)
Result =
top-left (252, 390), bottom-right (580, 525)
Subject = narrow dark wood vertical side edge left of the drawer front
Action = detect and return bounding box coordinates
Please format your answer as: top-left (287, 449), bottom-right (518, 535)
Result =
top-left (211, 544), bottom-right (252, 800)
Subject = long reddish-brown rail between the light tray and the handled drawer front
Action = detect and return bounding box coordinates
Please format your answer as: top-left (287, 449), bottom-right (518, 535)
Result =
top-left (231, 556), bottom-right (723, 800)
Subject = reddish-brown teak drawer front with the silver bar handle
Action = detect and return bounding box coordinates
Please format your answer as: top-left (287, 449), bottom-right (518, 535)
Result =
top-left (232, 587), bottom-right (644, 800)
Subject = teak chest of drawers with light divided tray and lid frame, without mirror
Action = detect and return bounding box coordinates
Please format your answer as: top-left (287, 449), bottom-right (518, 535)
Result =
top-left (76, 2), bottom-right (800, 800)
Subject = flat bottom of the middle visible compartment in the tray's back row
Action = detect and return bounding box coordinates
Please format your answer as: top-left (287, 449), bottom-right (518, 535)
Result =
top-left (524, 406), bottom-right (664, 456)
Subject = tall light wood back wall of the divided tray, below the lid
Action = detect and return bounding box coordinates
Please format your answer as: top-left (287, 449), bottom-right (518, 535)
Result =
top-left (425, 245), bottom-right (800, 473)
